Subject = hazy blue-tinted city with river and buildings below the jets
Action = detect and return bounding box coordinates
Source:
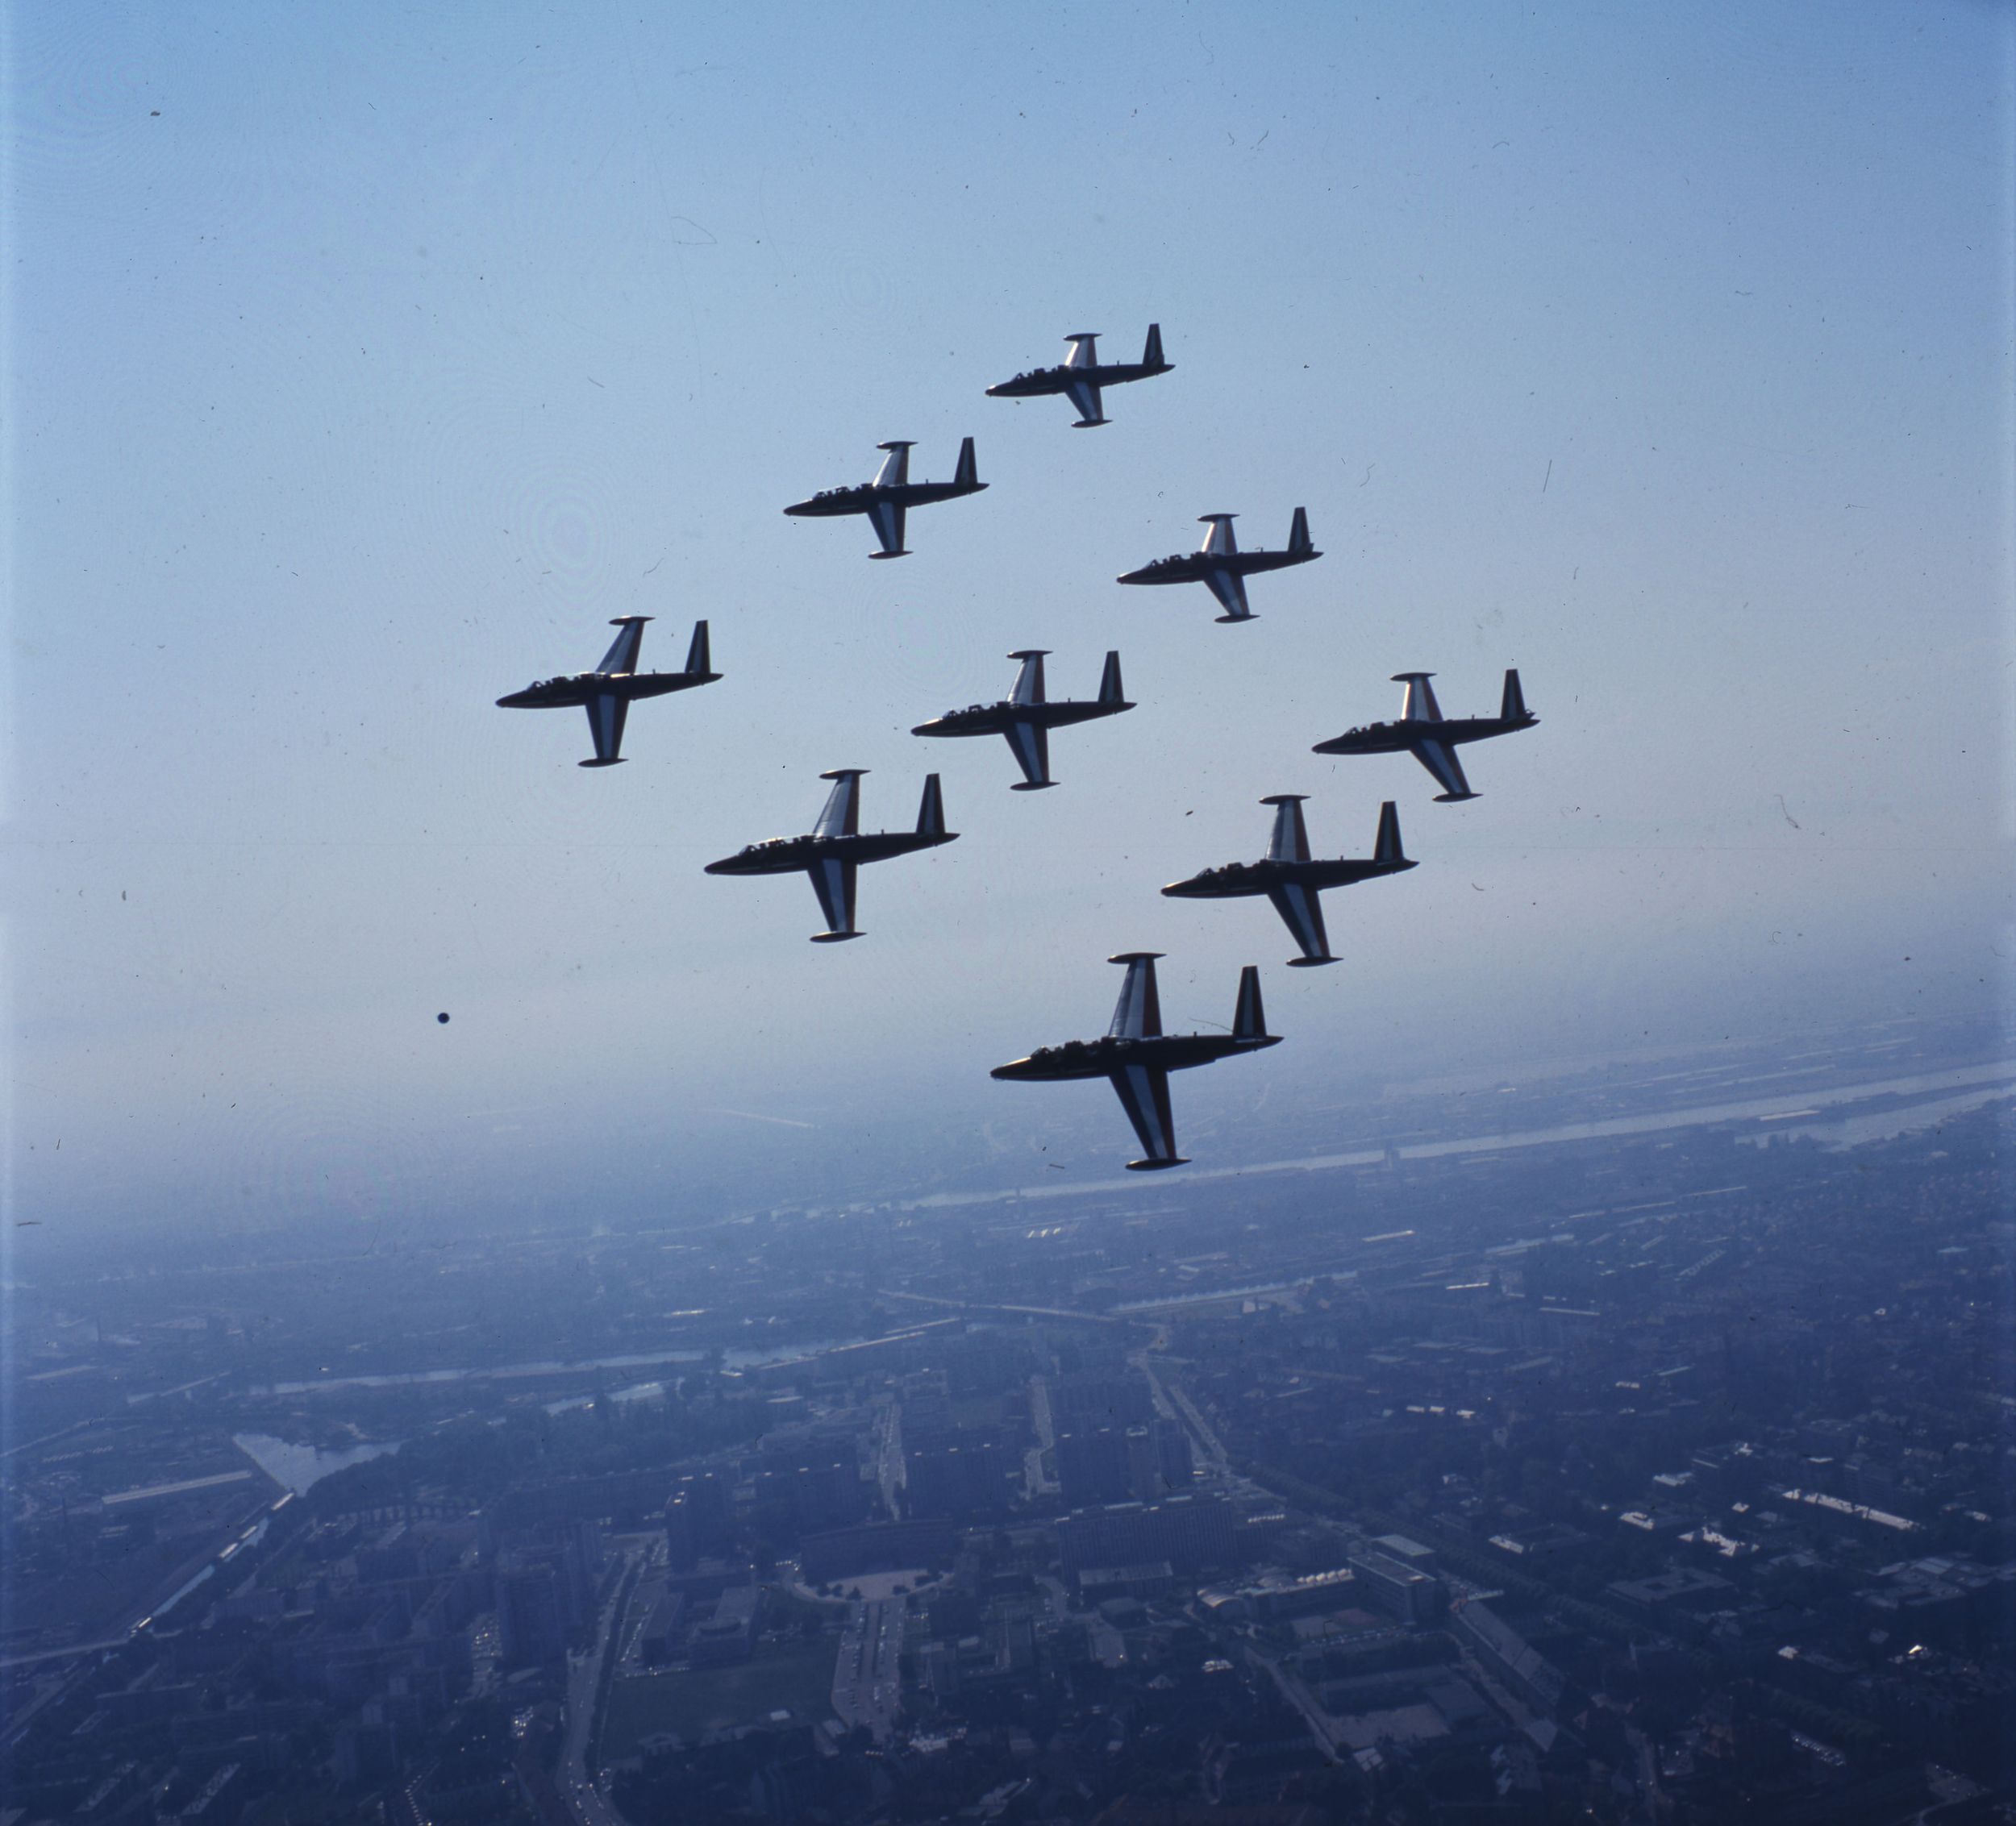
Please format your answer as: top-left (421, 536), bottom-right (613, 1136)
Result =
top-left (0, 1022), bottom-right (2016, 1826)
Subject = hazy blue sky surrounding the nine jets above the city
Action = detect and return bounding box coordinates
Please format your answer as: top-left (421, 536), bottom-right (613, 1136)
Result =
top-left (0, 4), bottom-right (2016, 1232)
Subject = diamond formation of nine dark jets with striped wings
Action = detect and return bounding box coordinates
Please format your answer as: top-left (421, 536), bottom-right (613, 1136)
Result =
top-left (496, 325), bottom-right (1539, 1171)
